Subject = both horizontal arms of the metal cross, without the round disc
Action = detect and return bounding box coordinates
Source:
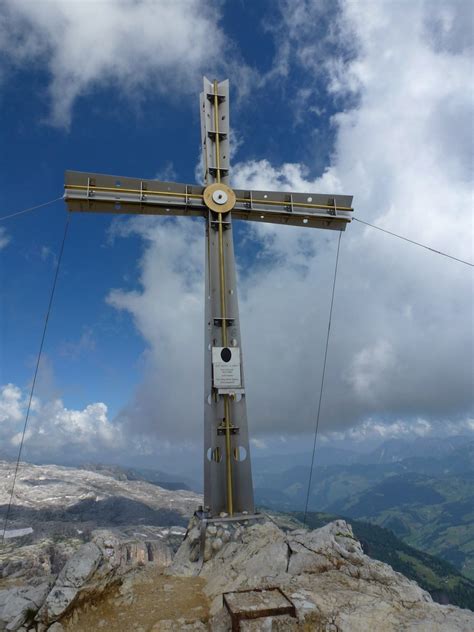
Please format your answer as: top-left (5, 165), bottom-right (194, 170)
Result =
top-left (64, 171), bottom-right (353, 230)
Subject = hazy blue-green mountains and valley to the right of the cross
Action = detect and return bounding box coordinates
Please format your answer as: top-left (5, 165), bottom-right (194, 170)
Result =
top-left (254, 437), bottom-right (474, 579)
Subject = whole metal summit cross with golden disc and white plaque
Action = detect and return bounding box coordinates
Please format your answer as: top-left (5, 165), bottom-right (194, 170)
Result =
top-left (64, 77), bottom-right (352, 517)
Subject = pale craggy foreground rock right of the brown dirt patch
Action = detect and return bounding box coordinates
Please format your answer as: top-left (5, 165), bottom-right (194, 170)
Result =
top-left (169, 520), bottom-right (474, 632)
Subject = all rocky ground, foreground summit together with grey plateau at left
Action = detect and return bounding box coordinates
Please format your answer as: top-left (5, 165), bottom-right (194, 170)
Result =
top-left (0, 465), bottom-right (474, 632)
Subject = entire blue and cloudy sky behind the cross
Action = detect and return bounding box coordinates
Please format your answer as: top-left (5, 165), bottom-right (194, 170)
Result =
top-left (0, 0), bottom-right (474, 469)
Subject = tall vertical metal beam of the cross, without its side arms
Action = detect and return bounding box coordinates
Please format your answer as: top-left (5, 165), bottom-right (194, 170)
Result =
top-left (200, 78), bottom-right (255, 516)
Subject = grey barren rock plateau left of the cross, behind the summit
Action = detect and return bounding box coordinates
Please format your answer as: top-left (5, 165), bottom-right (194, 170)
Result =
top-left (0, 461), bottom-right (196, 582)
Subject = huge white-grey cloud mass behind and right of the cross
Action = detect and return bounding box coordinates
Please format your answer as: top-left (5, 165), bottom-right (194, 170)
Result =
top-left (102, 2), bottom-right (473, 440)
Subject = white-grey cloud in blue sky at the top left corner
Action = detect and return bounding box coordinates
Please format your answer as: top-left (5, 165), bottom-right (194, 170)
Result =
top-left (0, 0), bottom-right (230, 126)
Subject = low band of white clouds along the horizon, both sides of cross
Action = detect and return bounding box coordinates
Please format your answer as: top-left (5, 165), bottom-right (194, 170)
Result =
top-left (0, 384), bottom-right (474, 464)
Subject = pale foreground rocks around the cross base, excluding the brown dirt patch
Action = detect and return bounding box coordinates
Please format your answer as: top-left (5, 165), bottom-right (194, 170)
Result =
top-left (0, 520), bottom-right (474, 632)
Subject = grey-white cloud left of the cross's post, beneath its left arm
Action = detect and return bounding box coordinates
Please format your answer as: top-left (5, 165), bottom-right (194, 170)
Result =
top-left (108, 217), bottom-right (204, 444)
